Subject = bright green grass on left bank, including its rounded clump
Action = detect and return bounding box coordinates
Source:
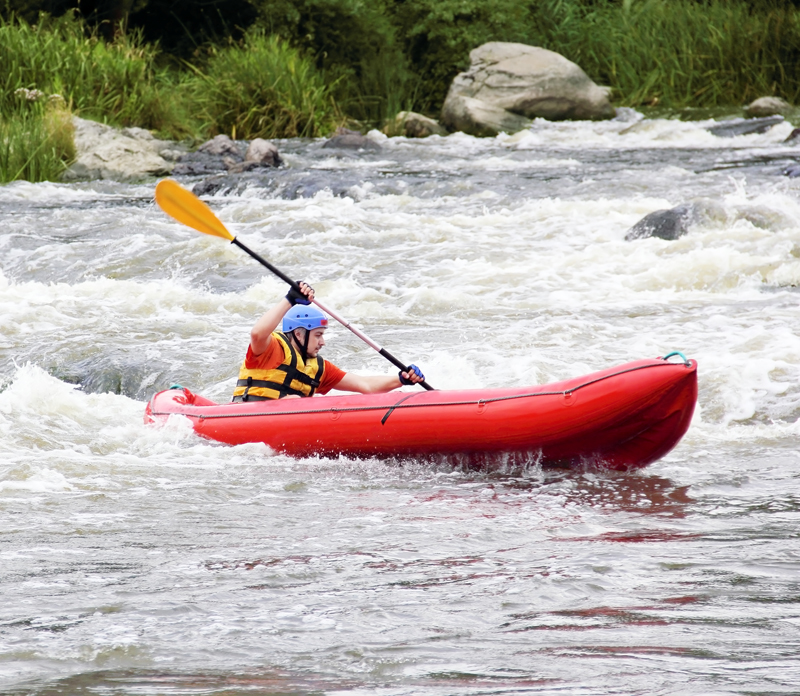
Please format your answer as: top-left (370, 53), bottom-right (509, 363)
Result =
top-left (0, 15), bottom-right (342, 183)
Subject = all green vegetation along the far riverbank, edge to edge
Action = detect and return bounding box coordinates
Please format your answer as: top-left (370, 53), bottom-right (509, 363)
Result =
top-left (0, 0), bottom-right (800, 181)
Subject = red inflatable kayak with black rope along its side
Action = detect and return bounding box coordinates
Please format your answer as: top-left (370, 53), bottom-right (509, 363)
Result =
top-left (145, 358), bottom-right (697, 469)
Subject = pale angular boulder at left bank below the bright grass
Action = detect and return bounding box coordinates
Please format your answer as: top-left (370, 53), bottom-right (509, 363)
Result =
top-left (62, 117), bottom-right (185, 181)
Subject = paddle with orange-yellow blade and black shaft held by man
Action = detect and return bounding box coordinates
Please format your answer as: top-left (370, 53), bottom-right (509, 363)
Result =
top-left (156, 179), bottom-right (433, 391)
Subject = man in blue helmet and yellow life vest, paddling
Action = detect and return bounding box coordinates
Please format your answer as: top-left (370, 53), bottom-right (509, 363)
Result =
top-left (233, 281), bottom-right (425, 401)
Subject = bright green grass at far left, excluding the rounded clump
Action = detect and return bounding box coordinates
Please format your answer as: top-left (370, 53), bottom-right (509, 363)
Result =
top-left (0, 15), bottom-right (191, 182)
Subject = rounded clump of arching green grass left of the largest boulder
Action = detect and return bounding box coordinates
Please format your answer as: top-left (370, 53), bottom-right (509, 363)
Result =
top-left (189, 31), bottom-right (341, 139)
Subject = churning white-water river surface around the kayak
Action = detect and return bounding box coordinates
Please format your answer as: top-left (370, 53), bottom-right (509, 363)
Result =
top-left (0, 112), bottom-right (800, 696)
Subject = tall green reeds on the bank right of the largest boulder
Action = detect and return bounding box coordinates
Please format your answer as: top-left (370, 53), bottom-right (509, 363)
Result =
top-left (528, 0), bottom-right (800, 107)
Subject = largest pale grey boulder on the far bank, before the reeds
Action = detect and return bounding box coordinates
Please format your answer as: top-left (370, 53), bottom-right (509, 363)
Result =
top-left (441, 41), bottom-right (616, 135)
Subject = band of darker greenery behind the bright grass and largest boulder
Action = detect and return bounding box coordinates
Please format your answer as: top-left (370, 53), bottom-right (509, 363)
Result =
top-left (0, 0), bottom-right (800, 124)
